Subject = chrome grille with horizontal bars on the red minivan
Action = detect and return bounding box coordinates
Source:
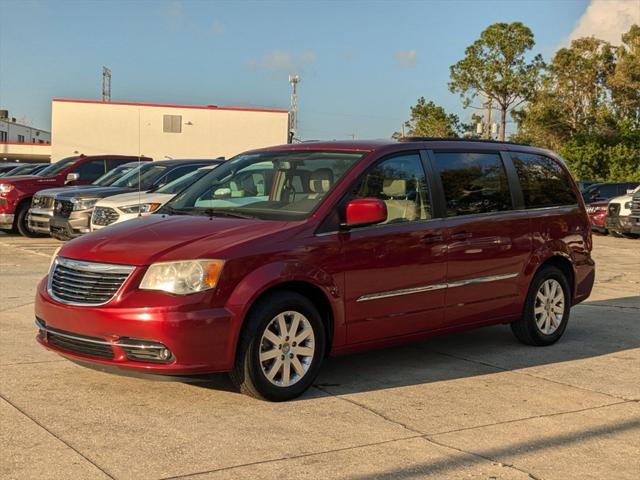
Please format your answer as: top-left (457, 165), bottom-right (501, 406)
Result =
top-left (49, 257), bottom-right (135, 305)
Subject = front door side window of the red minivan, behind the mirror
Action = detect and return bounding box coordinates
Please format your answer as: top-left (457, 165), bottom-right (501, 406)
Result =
top-left (354, 153), bottom-right (432, 223)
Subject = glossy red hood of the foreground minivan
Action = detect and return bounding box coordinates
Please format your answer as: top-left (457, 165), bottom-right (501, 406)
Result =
top-left (59, 215), bottom-right (299, 265)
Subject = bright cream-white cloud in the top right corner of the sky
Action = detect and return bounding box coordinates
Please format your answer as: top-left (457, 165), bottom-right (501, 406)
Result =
top-left (566, 0), bottom-right (640, 45)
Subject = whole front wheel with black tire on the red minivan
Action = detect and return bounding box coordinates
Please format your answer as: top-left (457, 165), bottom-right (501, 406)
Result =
top-left (229, 291), bottom-right (326, 402)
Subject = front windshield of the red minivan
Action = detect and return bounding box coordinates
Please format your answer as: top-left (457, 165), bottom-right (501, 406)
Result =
top-left (162, 151), bottom-right (364, 220)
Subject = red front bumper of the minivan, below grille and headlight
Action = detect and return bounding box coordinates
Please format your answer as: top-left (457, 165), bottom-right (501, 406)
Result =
top-left (35, 278), bottom-right (235, 375)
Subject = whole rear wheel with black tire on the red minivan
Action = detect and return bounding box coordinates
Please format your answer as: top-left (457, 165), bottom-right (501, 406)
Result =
top-left (511, 265), bottom-right (571, 346)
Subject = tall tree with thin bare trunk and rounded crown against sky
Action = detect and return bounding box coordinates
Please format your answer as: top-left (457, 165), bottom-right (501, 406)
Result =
top-left (449, 22), bottom-right (544, 140)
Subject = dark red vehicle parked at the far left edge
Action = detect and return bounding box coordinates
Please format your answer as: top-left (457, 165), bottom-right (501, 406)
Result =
top-left (0, 155), bottom-right (151, 237)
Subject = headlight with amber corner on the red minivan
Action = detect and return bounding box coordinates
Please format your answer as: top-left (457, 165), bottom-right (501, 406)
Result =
top-left (140, 260), bottom-right (224, 295)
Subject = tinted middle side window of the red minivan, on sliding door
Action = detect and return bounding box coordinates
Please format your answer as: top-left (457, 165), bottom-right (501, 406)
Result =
top-left (434, 152), bottom-right (513, 217)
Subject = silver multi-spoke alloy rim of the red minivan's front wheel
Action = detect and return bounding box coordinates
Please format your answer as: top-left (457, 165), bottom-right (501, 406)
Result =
top-left (259, 311), bottom-right (315, 387)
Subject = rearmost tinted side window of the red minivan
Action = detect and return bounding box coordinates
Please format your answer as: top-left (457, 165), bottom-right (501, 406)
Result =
top-left (511, 152), bottom-right (577, 208)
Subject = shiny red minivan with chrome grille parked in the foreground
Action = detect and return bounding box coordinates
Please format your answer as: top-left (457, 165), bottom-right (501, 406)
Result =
top-left (35, 139), bottom-right (595, 401)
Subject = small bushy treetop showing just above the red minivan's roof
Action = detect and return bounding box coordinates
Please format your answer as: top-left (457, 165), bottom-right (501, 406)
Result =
top-left (392, 97), bottom-right (463, 138)
